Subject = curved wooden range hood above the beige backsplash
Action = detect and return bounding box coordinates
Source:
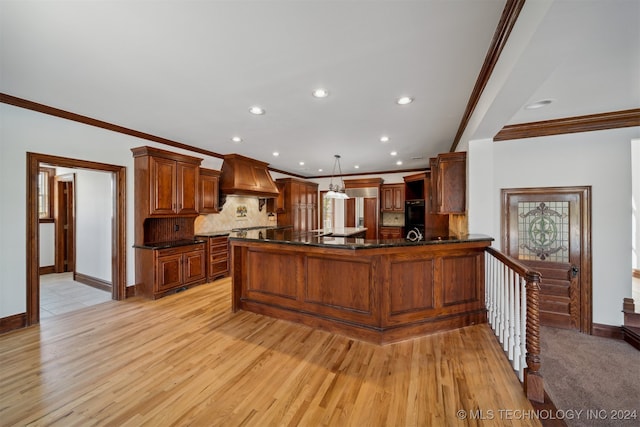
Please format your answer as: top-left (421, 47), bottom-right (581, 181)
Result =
top-left (220, 154), bottom-right (279, 198)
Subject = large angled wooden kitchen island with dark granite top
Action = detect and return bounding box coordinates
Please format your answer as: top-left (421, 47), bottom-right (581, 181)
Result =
top-left (230, 229), bottom-right (493, 344)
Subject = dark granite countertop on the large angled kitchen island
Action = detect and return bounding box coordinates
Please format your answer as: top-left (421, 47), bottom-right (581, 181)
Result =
top-left (229, 228), bottom-right (493, 249)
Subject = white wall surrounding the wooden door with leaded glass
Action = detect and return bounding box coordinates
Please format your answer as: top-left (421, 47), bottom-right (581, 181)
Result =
top-left (468, 128), bottom-right (640, 325)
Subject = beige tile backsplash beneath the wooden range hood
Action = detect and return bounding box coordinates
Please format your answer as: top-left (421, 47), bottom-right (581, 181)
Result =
top-left (194, 195), bottom-right (277, 234)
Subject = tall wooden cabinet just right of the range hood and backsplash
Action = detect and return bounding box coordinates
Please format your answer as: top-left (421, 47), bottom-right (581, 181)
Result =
top-left (276, 178), bottom-right (318, 231)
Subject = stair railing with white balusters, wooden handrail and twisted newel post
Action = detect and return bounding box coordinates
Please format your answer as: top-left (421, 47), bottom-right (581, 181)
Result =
top-left (485, 247), bottom-right (544, 402)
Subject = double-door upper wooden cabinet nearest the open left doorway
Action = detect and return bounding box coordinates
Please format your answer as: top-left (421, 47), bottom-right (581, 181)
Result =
top-left (131, 147), bottom-right (202, 217)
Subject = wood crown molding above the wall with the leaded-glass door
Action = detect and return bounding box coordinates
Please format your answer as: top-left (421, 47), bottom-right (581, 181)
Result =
top-left (493, 108), bottom-right (640, 142)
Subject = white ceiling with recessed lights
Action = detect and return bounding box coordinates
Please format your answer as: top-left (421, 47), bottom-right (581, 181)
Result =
top-left (0, 0), bottom-right (640, 176)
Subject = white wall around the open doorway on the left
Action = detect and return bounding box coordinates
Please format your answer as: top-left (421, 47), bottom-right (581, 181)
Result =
top-left (0, 104), bottom-right (225, 318)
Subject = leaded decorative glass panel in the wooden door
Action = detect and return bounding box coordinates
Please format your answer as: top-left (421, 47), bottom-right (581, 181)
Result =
top-left (518, 202), bottom-right (569, 263)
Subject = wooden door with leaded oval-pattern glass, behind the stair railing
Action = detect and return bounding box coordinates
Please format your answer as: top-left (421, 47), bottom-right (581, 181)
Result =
top-left (502, 187), bottom-right (591, 333)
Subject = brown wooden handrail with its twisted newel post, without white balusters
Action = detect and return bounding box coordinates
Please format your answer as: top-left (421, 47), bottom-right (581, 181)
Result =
top-left (486, 247), bottom-right (544, 402)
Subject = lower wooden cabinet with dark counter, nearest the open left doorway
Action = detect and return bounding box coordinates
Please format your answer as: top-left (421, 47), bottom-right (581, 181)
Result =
top-left (136, 243), bottom-right (207, 299)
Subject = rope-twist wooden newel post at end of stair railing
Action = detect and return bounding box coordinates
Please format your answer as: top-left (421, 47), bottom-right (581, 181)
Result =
top-left (524, 274), bottom-right (544, 403)
